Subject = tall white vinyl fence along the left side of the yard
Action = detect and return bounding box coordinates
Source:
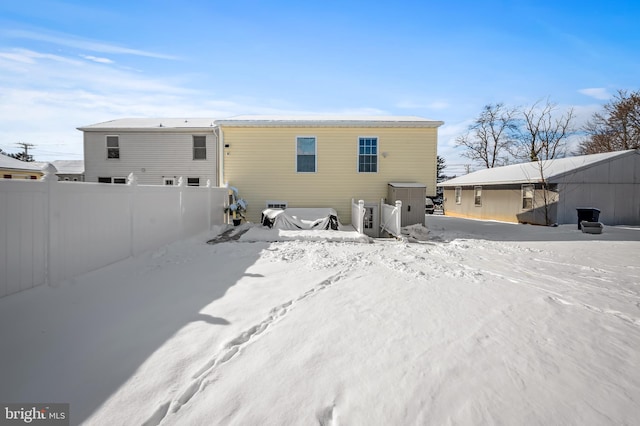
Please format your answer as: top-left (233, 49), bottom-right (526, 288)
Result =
top-left (0, 171), bottom-right (228, 297)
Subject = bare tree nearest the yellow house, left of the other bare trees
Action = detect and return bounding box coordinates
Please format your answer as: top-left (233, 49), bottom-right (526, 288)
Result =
top-left (456, 103), bottom-right (518, 169)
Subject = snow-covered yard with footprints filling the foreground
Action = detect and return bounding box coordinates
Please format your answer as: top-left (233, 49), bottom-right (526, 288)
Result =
top-left (0, 216), bottom-right (640, 425)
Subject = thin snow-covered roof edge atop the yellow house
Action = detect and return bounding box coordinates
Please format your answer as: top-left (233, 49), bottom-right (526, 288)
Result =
top-left (215, 115), bottom-right (444, 127)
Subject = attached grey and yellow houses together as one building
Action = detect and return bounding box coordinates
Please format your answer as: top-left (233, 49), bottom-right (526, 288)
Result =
top-left (80, 116), bottom-right (443, 228)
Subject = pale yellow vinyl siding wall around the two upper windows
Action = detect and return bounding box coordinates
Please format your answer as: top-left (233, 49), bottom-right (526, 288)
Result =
top-left (221, 126), bottom-right (437, 223)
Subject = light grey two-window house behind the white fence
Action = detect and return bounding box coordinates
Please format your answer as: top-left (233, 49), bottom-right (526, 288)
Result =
top-left (78, 118), bottom-right (218, 186)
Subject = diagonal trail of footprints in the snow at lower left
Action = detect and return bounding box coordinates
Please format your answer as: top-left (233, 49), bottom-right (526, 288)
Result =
top-left (143, 270), bottom-right (346, 426)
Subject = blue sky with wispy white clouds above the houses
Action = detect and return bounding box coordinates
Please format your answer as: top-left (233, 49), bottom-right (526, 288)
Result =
top-left (0, 0), bottom-right (640, 174)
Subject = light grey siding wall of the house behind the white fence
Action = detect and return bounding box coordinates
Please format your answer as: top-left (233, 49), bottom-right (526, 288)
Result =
top-left (84, 129), bottom-right (218, 186)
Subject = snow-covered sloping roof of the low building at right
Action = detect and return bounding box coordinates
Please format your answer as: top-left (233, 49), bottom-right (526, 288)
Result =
top-left (438, 149), bottom-right (639, 187)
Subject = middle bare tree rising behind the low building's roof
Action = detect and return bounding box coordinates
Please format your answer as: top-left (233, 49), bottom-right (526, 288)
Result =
top-left (512, 99), bottom-right (575, 161)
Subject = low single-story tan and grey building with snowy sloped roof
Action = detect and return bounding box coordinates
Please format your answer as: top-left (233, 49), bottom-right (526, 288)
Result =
top-left (438, 150), bottom-right (640, 225)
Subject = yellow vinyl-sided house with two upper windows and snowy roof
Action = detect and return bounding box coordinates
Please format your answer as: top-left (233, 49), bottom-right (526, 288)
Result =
top-left (215, 116), bottom-right (443, 235)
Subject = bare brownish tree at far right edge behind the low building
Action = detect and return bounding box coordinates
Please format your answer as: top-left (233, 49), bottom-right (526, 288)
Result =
top-left (578, 90), bottom-right (640, 154)
